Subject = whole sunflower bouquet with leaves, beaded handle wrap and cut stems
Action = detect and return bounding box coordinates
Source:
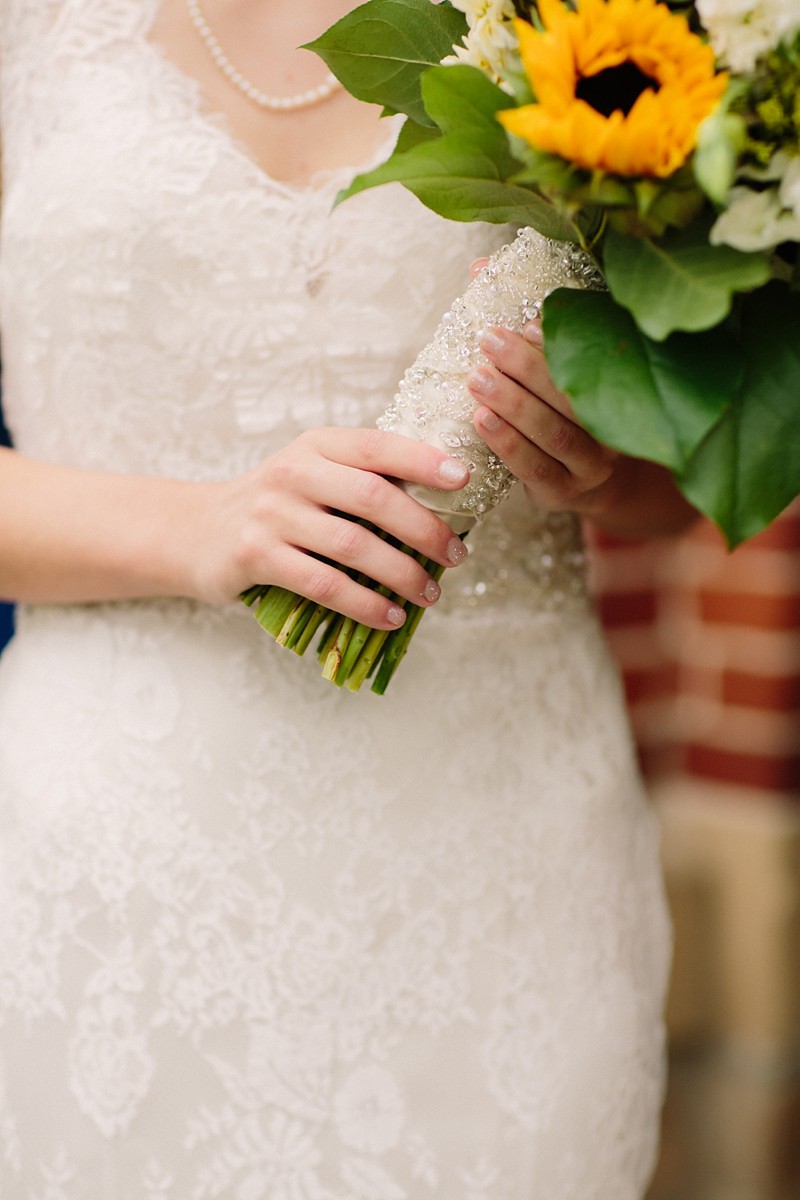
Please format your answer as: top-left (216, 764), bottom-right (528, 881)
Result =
top-left (245, 0), bottom-right (800, 691)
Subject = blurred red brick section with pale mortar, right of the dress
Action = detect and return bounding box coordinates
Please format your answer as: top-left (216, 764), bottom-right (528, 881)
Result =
top-left (593, 506), bottom-right (800, 804)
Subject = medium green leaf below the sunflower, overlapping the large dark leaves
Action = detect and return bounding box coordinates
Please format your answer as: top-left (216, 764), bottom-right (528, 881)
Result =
top-left (603, 223), bottom-right (770, 341)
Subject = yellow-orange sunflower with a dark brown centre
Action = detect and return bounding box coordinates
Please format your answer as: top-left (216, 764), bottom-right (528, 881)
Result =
top-left (498, 0), bottom-right (727, 179)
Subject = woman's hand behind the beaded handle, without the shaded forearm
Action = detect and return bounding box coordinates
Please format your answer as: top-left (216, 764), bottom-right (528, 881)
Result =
top-left (467, 322), bottom-right (620, 511)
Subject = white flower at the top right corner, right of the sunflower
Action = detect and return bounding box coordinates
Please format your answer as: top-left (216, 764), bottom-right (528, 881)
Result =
top-left (696, 0), bottom-right (800, 74)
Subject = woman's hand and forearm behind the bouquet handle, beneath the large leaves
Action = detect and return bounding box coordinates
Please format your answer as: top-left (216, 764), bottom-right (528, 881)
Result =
top-left (469, 323), bottom-right (697, 538)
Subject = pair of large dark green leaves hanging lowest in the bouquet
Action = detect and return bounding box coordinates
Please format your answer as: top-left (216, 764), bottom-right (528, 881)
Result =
top-left (543, 282), bottom-right (800, 547)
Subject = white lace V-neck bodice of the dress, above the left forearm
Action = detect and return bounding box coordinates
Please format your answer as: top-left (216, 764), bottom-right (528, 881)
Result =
top-left (0, 0), bottom-right (503, 478)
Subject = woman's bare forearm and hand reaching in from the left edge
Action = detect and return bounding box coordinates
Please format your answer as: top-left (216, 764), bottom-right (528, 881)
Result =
top-left (0, 430), bottom-right (467, 629)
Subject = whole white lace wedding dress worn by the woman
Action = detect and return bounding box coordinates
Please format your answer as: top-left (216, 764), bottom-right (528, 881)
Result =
top-left (0, 0), bottom-right (669, 1200)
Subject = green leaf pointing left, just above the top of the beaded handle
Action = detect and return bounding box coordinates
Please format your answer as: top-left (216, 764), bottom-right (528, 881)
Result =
top-left (337, 133), bottom-right (575, 232)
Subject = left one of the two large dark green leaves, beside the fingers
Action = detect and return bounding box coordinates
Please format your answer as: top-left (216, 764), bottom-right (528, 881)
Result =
top-left (543, 288), bottom-right (742, 470)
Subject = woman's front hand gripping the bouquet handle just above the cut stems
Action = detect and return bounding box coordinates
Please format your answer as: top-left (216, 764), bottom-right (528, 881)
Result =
top-left (190, 428), bottom-right (469, 629)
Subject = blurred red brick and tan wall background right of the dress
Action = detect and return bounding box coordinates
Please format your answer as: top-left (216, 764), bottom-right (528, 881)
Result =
top-left (0, 391), bottom-right (800, 1200)
